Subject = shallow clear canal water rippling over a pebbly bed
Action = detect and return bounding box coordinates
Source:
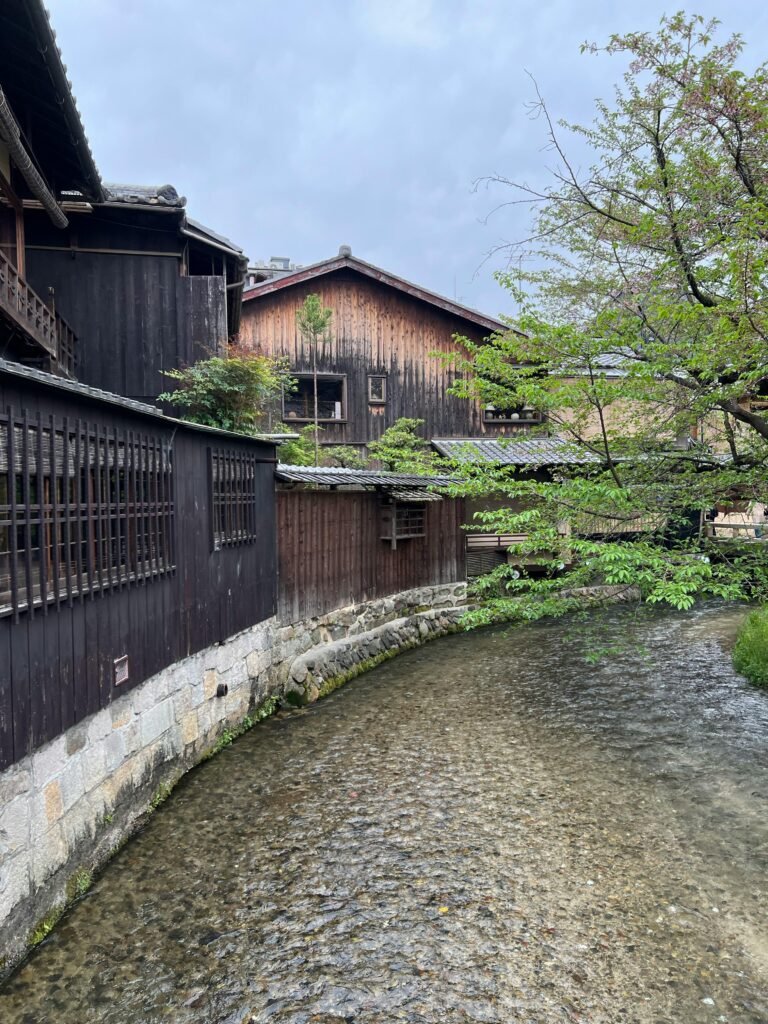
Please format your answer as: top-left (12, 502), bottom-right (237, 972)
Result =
top-left (0, 607), bottom-right (768, 1024)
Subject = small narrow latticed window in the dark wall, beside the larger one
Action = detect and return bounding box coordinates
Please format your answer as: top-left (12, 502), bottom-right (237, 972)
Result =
top-left (210, 449), bottom-right (258, 550)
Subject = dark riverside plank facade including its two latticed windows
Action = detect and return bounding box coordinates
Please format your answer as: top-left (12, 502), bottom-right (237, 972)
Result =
top-left (0, 364), bottom-right (276, 769)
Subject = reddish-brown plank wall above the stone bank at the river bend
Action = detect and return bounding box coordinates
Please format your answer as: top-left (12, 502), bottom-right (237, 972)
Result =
top-left (278, 490), bottom-right (465, 622)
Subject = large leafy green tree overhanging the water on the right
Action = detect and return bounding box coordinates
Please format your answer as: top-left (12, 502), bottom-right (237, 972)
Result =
top-left (456, 13), bottom-right (768, 618)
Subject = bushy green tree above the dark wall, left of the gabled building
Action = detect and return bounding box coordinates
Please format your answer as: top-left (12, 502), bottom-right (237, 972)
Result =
top-left (159, 355), bottom-right (292, 434)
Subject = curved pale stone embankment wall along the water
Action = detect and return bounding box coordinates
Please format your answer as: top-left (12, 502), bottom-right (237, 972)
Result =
top-left (0, 583), bottom-right (466, 976)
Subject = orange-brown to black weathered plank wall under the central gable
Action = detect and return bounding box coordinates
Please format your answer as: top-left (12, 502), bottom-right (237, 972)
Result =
top-left (240, 269), bottom-right (515, 443)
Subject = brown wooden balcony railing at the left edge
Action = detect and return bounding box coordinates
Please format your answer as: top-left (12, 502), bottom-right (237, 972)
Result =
top-left (0, 252), bottom-right (77, 377)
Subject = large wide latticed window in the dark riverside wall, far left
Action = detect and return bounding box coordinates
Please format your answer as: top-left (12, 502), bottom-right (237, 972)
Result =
top-left (0, 415), bottom-right (174, 615)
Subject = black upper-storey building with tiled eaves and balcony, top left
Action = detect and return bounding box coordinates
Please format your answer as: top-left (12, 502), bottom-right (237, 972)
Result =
top-left (0, 0), bottom-right (246, 400)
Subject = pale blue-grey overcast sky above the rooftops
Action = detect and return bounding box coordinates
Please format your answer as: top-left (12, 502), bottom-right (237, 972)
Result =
top-left (47, 0), bottom-right (768, 314)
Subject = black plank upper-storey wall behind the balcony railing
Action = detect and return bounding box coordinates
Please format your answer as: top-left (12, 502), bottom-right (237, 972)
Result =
top-left (26, 208), bottom-right (227, 401)
